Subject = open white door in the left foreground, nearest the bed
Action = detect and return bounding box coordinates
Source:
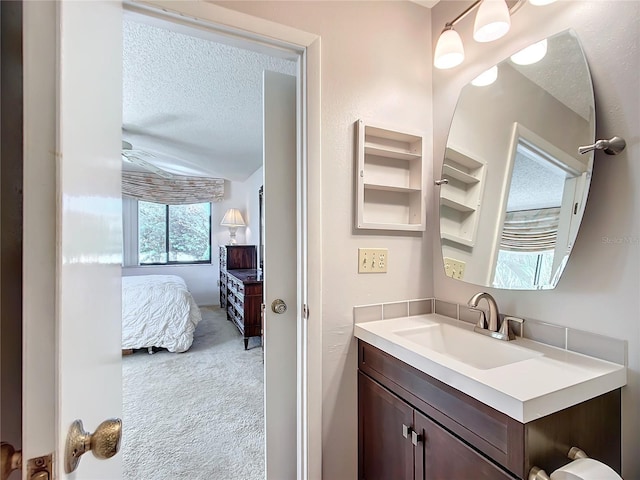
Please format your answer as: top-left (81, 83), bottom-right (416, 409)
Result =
top-left (23, 1), bottom-right (122, 480)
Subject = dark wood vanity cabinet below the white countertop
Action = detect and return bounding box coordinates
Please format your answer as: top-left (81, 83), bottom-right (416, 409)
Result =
top-left (358, 340), bottom-right (621, 480)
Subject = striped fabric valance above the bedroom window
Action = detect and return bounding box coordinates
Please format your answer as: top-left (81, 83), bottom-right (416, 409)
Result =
top-left (122, 172), bottom-right (224, 205)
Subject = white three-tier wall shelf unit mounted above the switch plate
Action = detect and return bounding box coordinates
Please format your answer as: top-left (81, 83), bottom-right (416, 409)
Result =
top-left (356, 120), bottom-right (425, 231)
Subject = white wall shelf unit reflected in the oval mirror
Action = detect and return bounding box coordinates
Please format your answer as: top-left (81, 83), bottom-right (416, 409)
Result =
top-left (440, 147), bottom-right (485, 247)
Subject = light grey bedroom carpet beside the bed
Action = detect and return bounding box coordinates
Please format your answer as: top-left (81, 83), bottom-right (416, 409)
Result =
top-left (122, 307), bottom-right (264, 480)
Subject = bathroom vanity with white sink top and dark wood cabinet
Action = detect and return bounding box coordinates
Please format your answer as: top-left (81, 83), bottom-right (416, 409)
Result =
top-left (356, 315), bottom-right (626, 480)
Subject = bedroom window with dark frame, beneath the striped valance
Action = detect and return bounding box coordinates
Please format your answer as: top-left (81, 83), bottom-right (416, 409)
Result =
top-left (138, 201), bottom-right (211, 265)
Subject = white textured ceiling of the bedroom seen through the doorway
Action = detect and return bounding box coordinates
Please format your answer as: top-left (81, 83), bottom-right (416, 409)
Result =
top-left (122, 19), bottom-right (296, 181)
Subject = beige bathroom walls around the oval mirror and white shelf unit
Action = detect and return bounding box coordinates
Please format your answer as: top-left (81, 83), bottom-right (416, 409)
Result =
top-left (217, 0), bottom-right (640, 480)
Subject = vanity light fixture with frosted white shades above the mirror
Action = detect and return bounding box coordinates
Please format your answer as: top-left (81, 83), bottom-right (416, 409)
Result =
top-left (433, 0), bottom-right (555, 70)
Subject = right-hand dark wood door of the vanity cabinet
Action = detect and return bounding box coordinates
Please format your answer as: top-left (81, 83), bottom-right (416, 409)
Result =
top-left (414, 411), bottom-right (516, 480)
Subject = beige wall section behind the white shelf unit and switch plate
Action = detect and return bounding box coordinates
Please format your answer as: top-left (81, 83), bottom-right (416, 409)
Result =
top-left (216, 1), bottom-right (435, 480)
